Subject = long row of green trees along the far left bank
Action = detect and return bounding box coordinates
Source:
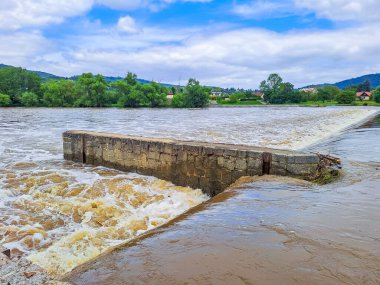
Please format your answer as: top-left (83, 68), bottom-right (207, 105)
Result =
top-left (0, 67), bottom-right (210, 108)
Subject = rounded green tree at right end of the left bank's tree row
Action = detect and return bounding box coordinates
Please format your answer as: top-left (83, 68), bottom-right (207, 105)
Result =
top-left (183, 78), bottom-right (210, 108)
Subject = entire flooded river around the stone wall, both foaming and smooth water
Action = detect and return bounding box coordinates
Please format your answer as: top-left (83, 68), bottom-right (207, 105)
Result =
top-left (0, 107), bottom-right (380, 284)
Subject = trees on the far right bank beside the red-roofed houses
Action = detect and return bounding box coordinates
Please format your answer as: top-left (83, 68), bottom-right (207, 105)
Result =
top-left (260, 73), bottom-right (380, 104)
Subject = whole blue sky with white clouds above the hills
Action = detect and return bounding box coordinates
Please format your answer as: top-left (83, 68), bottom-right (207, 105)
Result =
top-left (0, 0), bottom-right (380, 89)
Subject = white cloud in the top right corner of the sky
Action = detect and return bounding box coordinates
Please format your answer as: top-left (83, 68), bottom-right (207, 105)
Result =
top-left (295, 0), bottom-right (380, 22)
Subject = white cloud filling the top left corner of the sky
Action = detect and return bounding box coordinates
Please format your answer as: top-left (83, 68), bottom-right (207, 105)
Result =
top-left (0, 0), bottom-right (93, 30)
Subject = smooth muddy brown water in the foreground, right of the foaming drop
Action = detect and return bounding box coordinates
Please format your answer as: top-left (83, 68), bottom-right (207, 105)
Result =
top-left (66, 114), bottom-right (380, 285)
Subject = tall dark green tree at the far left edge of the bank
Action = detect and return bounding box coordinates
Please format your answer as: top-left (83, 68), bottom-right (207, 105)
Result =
top-left (0, 67), bottom-right (41, 105)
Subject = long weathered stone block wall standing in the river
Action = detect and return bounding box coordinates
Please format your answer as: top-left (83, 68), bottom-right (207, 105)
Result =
top-left (63, 131), bottom-right (336, 196)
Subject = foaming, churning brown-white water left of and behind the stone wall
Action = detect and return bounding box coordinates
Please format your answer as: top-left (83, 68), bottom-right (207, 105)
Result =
top-left (0, 108), bottom-right (374, 275)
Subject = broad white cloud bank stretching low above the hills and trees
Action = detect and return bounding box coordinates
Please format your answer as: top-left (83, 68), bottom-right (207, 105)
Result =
top-left (17, 21), bottom-right (380, 88)
